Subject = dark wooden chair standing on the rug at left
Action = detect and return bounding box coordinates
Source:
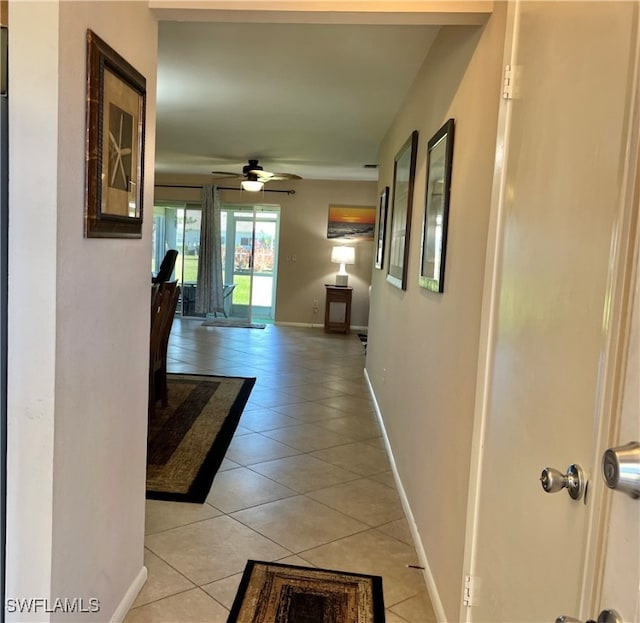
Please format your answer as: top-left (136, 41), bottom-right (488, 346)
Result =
top-left (149, 281), bottom-right (180, 416)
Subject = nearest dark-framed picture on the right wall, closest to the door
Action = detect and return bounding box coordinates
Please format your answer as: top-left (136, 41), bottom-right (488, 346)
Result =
top-left (420, 119), bottom-right (454, 292)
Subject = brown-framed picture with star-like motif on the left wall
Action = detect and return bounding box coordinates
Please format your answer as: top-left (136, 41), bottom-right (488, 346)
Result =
top-left (85, 30), bottom-right (146, 238)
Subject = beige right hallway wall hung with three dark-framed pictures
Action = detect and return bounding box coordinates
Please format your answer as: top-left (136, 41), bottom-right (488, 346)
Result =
top-left (367, 5), bottom-right (505, 621)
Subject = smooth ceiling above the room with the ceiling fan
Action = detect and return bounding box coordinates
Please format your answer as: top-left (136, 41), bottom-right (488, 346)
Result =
top-left (156, 21), bottom-right (439, 180)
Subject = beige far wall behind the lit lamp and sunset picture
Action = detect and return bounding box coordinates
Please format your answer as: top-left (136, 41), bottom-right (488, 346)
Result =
top-left (156, 176), bottom-right (377, 328)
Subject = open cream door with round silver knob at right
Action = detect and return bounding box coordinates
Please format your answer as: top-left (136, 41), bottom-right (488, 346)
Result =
top-left (463, 1), bottom-right (638, 623)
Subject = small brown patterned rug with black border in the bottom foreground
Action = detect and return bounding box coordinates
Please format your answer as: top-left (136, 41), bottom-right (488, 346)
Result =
top-left (227, 560), bottom-right (385, 623)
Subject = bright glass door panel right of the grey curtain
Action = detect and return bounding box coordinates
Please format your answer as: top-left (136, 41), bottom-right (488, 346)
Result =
top-left (220, 204), bottom-right (280, 322)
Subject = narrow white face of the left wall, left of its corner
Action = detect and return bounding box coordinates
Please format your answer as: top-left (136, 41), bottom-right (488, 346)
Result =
top-left (6, 3), bottom-right (58, 598)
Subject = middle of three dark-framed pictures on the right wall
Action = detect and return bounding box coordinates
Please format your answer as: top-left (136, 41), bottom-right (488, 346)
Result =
top-left (387, 130), bottom-right (418, 290)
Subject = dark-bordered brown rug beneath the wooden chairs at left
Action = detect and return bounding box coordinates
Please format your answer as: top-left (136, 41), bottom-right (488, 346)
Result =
top-left (147, 374), bottom-right (256, 503)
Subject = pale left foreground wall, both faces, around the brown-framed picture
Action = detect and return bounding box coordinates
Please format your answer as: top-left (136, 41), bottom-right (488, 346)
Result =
top-left (7, 1), bottom-right (157, 621)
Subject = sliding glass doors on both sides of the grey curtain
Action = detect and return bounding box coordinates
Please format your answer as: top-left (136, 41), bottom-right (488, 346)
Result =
top-left (151, 202), bottom-right (280, 322)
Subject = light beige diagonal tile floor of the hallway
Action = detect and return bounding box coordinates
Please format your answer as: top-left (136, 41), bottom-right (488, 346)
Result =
top-left (126, 318), bottom-right (436, 623)
